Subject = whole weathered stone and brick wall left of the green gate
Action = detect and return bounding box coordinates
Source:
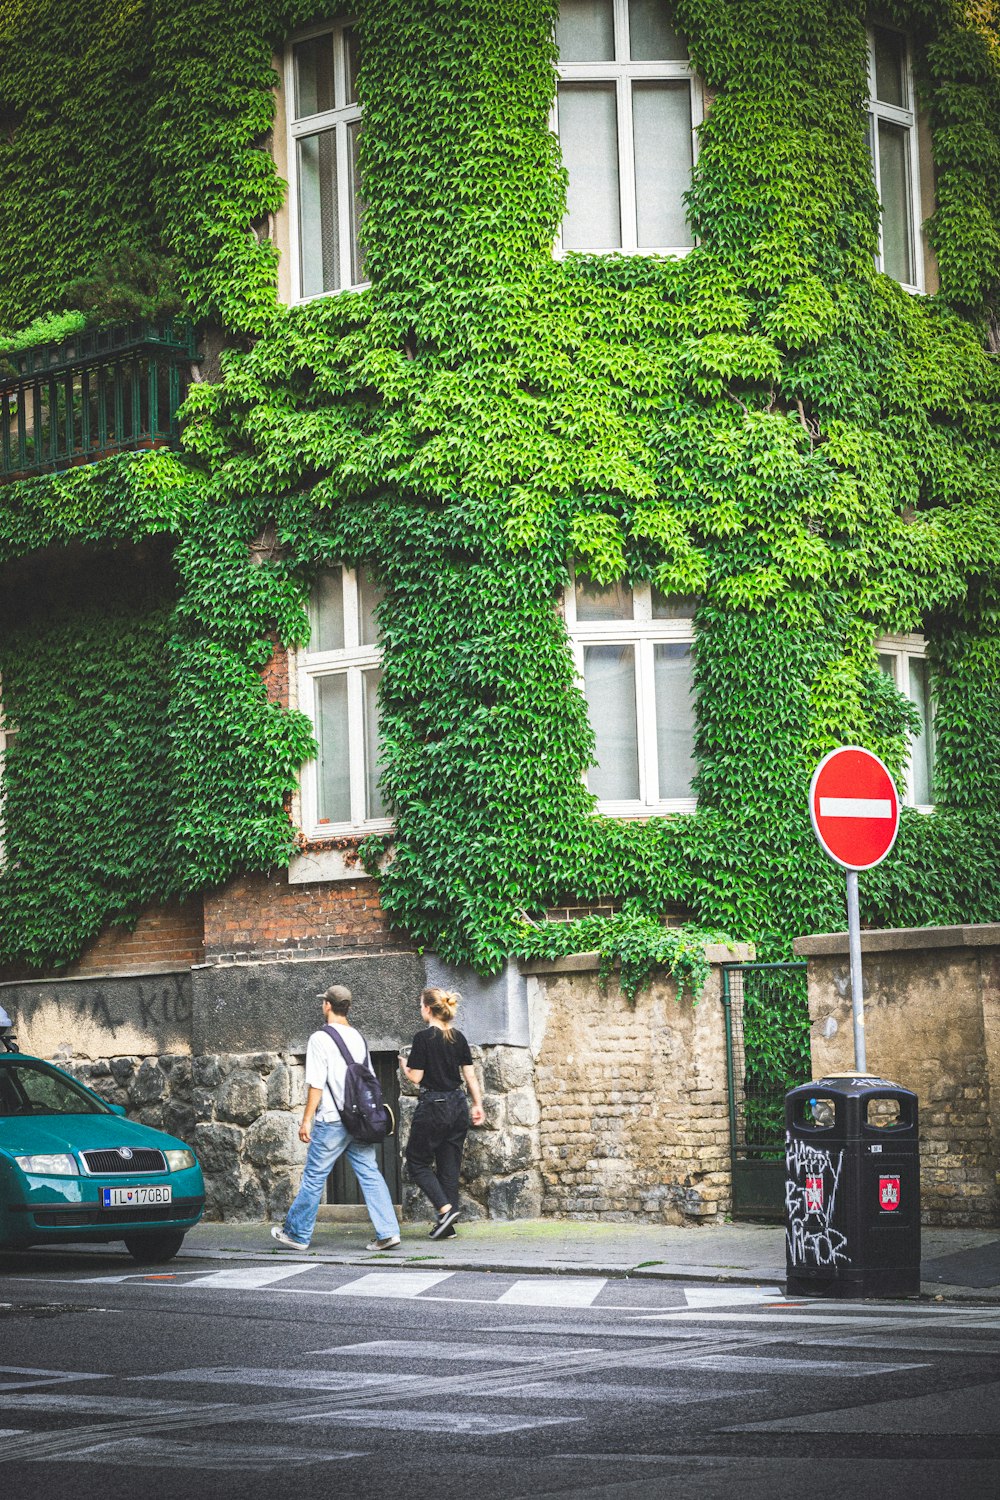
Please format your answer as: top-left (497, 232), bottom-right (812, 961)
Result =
top-left (0, 950), bottom-right (748, 1223)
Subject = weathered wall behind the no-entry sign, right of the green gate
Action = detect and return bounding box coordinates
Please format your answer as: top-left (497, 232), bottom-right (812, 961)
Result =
top-left (795, 924), bottom-right (1000, 1226)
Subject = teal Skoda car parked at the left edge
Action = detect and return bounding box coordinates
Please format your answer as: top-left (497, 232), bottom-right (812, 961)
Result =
top-left (0, 1044), bottom-right (205, 1265)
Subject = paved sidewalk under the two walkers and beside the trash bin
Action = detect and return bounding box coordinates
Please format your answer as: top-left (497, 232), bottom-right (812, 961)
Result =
top-left (146, 1218), bottom-right (1000, 1302)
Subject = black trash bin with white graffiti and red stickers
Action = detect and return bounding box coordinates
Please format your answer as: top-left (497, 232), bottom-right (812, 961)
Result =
top-left (784, 1074), bottom-right (921, 1298)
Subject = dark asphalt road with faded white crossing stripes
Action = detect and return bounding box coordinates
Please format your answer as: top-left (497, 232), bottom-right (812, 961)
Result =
top-left (0, 1253), bottom-right (1000, 1500)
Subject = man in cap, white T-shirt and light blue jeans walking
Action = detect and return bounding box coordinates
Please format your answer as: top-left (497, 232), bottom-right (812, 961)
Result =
top-left (271, 984), bottom-right (399, 1250)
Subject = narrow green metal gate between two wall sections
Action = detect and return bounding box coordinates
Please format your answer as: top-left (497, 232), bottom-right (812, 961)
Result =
top-left (723, 963), bottom-right (810, 1220)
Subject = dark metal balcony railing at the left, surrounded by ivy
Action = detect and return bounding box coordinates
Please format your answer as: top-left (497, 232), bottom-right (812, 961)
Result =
top-left (0, 320), bottom-right (198, 482)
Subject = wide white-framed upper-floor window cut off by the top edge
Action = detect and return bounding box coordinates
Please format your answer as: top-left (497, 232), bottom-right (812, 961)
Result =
top-left (553, 0), bottom-right (702, 255)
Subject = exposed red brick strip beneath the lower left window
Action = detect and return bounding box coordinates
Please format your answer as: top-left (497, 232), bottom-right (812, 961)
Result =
top-left (205, 870), bottom-right (412, 962)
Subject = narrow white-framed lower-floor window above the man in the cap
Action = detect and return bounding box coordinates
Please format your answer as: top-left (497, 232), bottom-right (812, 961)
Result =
top-left (297, 567), bottom-right (391, 839)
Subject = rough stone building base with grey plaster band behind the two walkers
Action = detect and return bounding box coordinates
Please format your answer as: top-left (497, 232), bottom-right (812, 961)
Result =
top-left (0, 954), bottom-right (541, 1220)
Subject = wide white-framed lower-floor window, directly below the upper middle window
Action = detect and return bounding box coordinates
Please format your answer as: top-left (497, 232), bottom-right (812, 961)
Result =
top-left (565, 576), bottom-right (696, 818)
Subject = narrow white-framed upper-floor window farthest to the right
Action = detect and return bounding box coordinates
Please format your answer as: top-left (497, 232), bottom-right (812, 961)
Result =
top-left (868, 26), bottom-right (924, 291)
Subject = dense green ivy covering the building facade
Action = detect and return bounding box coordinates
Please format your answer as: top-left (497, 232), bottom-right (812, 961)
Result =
top-left (0, 0), bottom-right (1000, 1080)
